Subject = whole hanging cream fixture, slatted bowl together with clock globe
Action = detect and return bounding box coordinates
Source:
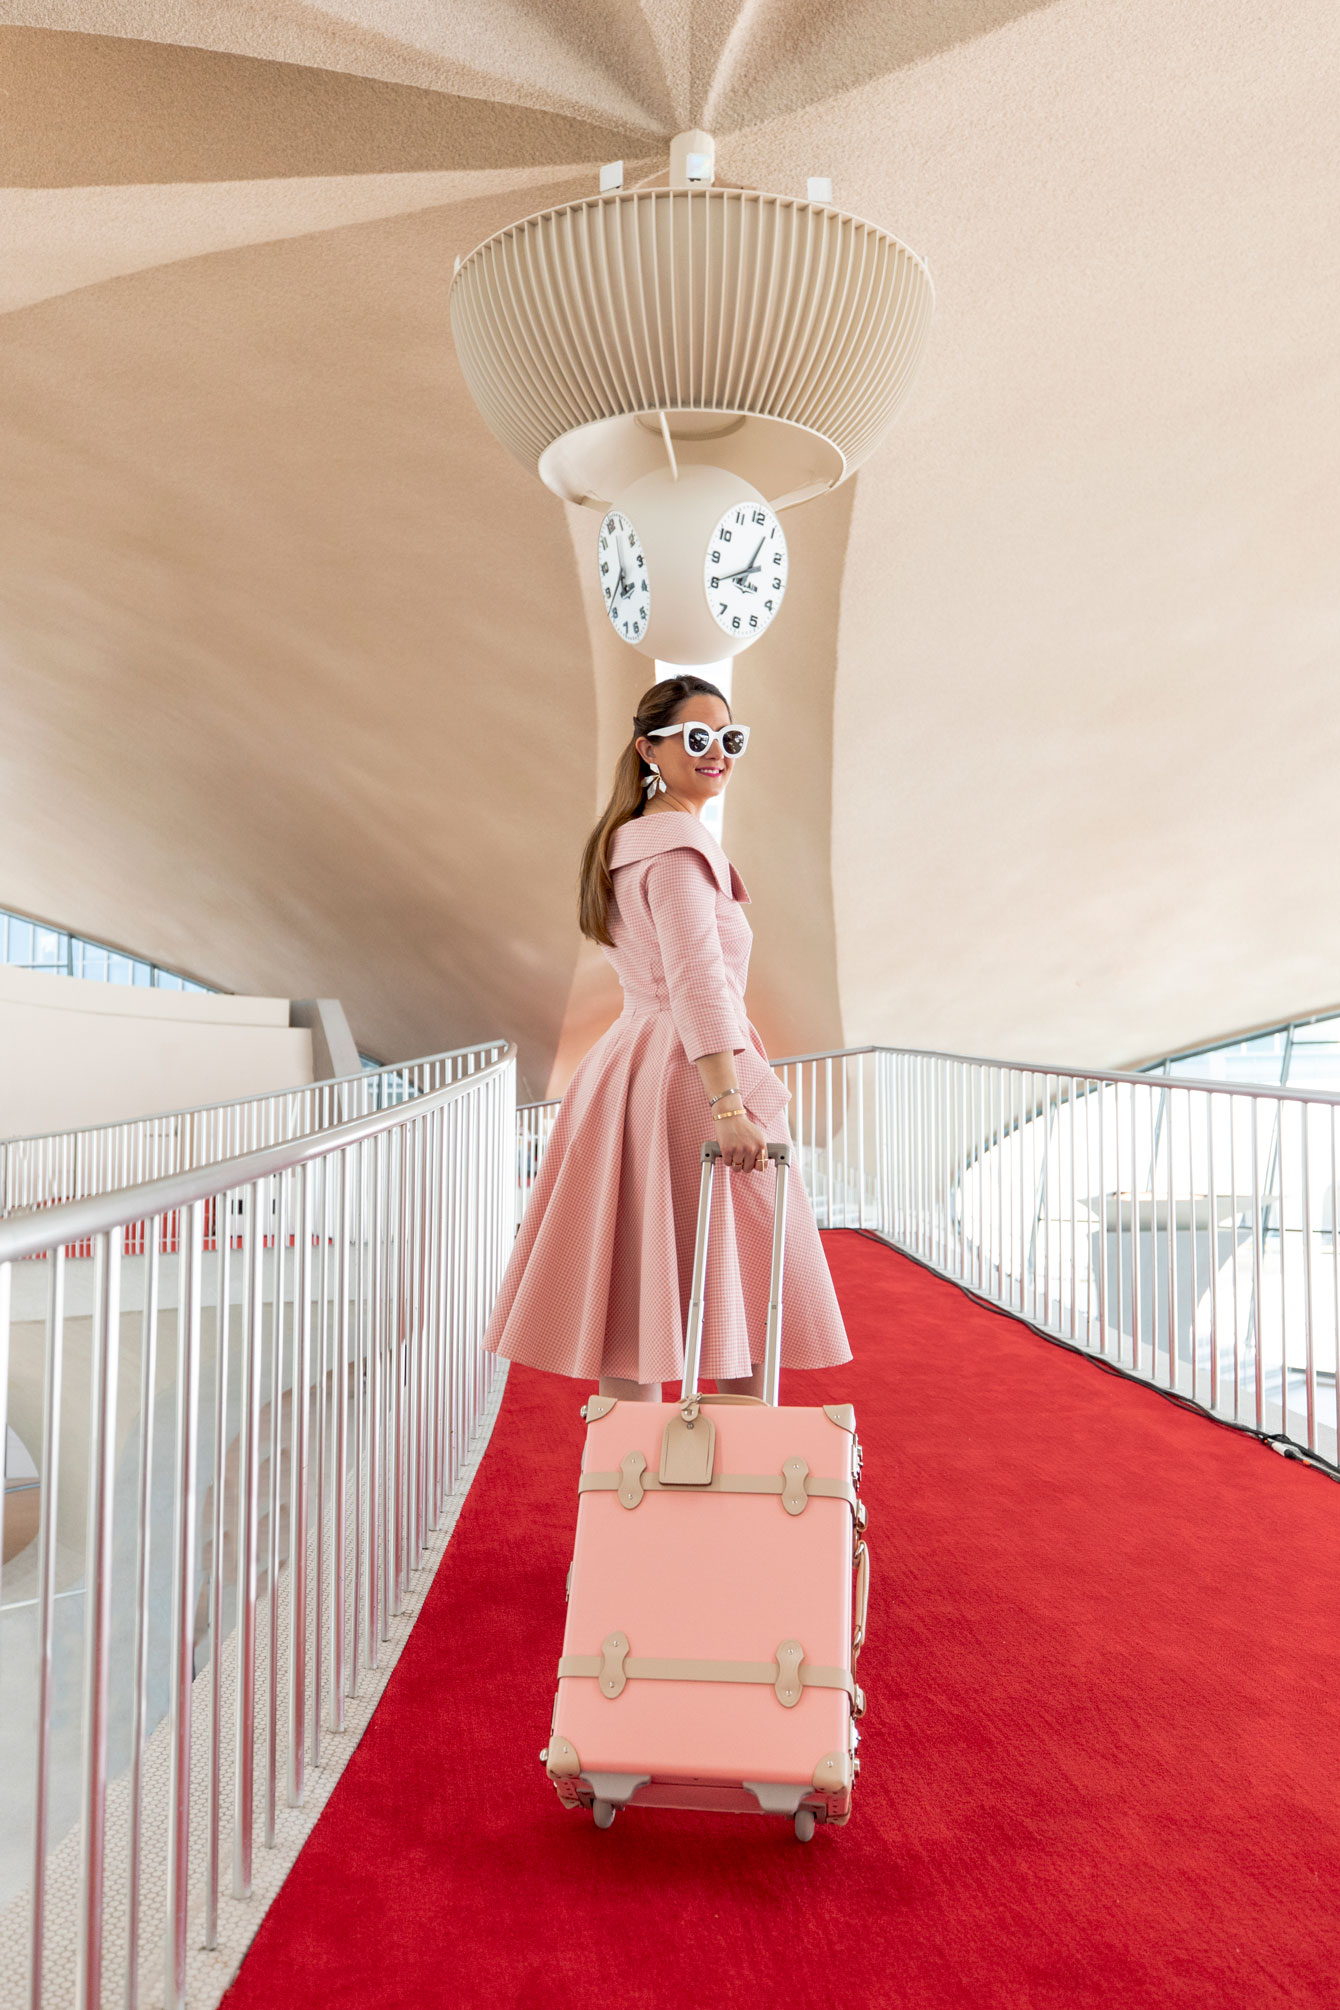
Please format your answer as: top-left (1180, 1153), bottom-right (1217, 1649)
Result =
top-left (452, 133), bottom-right (934, 663)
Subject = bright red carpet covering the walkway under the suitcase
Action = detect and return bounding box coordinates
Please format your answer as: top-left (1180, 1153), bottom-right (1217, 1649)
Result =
top-left (229, 1234), bottom-right (1340, 2010)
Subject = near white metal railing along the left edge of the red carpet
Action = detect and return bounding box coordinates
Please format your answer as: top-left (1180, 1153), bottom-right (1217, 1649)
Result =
top-left (0, 1049), bottom-right (516, 2010)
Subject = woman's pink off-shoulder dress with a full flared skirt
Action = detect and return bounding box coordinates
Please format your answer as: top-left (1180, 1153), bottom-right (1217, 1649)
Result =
top-left (484, 812), bottom-right (852, 1383)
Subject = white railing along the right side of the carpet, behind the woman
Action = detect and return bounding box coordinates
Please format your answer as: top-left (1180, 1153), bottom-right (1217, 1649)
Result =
top-left (518, 1047), bottom-right (1340, 1465)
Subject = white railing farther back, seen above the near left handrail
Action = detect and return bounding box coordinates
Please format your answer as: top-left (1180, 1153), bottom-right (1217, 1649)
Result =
top-left (0, 1039), bottom-right (506, 1214)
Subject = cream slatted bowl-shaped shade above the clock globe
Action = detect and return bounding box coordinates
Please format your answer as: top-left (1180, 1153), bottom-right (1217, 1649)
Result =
top-left (452, 135), bottom-right (932, 509)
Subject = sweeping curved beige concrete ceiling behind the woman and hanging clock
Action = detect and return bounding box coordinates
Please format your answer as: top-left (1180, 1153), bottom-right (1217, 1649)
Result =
top-left (0, 0), bottom-right (1340, 1093)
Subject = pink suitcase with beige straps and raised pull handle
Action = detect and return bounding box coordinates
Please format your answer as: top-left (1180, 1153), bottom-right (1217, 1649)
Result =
top-left (540, 1144), bottom-right (870, 1841)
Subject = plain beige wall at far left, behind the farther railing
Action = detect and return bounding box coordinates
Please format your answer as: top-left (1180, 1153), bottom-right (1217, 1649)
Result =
top-left (0, 967), bottom-right (311, 1138)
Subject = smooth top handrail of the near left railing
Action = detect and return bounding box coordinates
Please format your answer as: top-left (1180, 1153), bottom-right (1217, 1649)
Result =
top-left (0, 1045), bottom-right (516, 1264)
